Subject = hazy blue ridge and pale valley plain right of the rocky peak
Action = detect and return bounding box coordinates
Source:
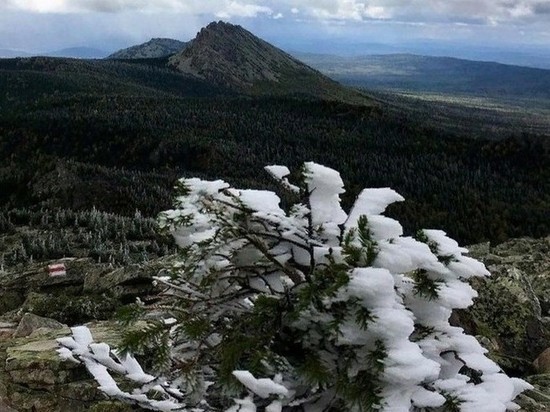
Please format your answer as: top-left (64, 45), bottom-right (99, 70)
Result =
top-left (295, 54), bottom-right (550, 137)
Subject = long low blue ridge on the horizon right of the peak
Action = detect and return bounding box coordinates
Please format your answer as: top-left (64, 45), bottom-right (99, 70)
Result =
top-left (296, 53), bottom-right (550, 99)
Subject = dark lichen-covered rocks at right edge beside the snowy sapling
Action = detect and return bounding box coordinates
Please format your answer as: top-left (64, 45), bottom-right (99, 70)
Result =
top-left (460, 237), bottom-right (550, 376)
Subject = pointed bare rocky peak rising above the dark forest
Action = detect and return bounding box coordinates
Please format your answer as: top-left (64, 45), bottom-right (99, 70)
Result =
top-left (168, 21), bottom-right (359, 100)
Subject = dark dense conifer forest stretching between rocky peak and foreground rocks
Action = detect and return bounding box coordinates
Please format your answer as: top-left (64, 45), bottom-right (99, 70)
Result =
top-left (0, 58), bottom-right (550, 268)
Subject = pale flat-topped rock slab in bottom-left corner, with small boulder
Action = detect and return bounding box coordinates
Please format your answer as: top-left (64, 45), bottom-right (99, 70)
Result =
top-left (0, 322), bottom-right (142, 412)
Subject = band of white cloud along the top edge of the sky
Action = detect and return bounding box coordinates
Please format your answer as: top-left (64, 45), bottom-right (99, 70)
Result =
top-left (0, 0), bottom-right (550, 25)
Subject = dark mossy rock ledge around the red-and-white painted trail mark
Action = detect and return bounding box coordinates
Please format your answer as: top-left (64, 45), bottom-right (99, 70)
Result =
top-left (0, 258), bottom-right (169, 326)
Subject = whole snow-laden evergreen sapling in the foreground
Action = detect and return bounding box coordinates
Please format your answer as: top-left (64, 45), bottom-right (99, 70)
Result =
top-left (60, 162), bottom-right (529, 412)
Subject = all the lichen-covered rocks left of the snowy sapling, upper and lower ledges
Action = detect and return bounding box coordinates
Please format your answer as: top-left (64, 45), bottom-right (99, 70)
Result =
top-left (0, 257), bottom-right (174, 412)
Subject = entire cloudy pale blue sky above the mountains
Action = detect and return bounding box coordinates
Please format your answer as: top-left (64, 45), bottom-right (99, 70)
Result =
top-left (0, 0), bottom-right (550, 52)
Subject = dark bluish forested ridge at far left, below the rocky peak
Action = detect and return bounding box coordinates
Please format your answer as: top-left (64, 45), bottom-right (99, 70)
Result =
top-left (0, 56), bottom-right (223, 100)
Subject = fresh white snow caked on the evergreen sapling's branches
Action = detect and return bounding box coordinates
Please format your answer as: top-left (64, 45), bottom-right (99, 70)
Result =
top-left (58, 162), bottom-right (530, 412)
